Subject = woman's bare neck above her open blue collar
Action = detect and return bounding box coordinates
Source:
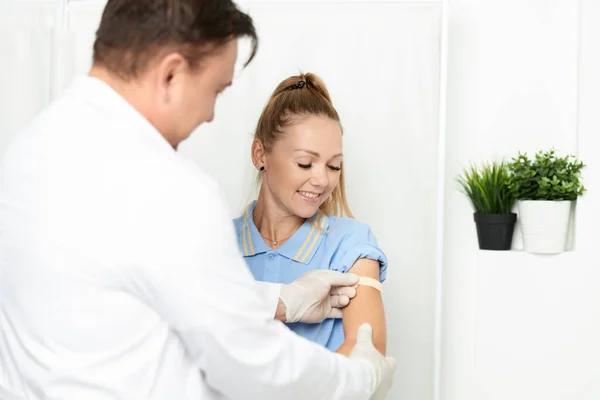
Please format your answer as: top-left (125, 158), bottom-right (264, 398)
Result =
top-left (252, 192), bottom-right (304, 246)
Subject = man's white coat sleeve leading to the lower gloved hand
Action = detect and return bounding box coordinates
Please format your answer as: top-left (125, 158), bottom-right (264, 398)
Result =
top-left (126, 174), bottom-right (372, 400)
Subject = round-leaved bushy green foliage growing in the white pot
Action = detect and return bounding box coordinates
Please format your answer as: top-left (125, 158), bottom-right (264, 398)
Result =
top-left (508, 149), bottom-right (586, 201)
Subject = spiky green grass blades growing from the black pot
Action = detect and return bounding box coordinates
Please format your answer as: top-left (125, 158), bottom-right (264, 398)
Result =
top-left (457, 161), bottom-right (515, 214)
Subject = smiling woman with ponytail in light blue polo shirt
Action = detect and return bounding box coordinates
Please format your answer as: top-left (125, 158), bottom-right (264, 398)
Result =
top-left (235, 74), bottom-right (387, 354)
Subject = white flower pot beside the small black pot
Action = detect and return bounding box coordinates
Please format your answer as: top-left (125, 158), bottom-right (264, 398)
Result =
top-left (518, 200), bottom-right (572, 254)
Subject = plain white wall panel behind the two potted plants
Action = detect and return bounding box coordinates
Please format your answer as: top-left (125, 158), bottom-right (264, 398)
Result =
top-left (440, 0), bottom-right (600, 400)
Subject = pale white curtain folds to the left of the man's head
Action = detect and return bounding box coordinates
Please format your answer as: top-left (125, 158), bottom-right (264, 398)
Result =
top-left (0, 3), bottom-right (102, 178)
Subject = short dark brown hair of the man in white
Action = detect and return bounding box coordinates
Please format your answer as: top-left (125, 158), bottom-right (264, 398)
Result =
top-left (93, 0), bottom-right (258, 79)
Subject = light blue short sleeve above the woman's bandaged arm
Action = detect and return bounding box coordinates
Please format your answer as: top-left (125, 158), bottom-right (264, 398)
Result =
top-left (331, 224), bottom-right (388, 283)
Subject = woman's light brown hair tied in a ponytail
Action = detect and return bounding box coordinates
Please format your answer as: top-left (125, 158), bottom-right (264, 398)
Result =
top-left (254, 73), bottom-right (354, 218)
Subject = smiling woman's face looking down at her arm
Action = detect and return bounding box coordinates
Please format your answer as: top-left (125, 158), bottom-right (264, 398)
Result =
top-left (263, 116), bottom-right (342, 218)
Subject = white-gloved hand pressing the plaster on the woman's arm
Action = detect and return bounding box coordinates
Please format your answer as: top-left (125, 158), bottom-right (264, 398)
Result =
top-left (279, 270), bottom-right (359, 323)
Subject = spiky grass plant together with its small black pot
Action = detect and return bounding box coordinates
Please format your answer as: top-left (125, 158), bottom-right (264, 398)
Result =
top-left (457, 161), bottom-right (517, 250)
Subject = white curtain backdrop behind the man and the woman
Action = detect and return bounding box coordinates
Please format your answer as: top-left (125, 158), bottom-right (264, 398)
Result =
top-left (0, 0), bottom-right (441, 400)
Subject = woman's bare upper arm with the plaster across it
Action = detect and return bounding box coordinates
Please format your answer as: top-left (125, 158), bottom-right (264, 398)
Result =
top-left (342, 258), bottom-right (386, 354)
